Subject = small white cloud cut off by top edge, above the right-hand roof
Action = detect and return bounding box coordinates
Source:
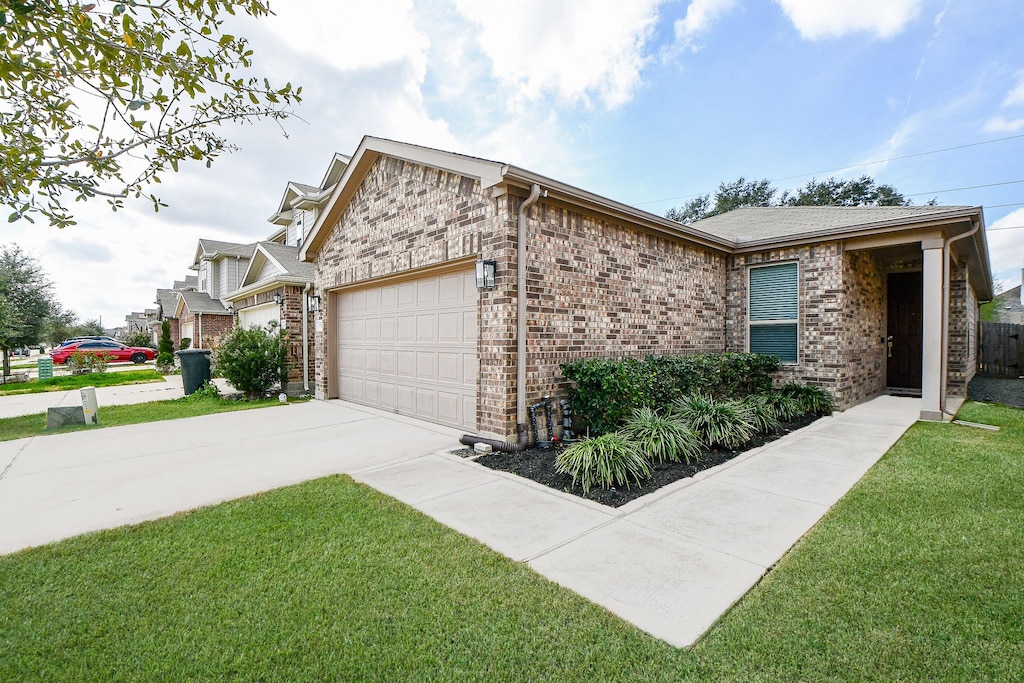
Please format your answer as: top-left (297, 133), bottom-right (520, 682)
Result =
top-left (775, 0), bottom-right (922, 40)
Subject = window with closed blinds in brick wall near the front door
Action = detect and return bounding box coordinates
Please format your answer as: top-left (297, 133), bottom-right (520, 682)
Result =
top-left (748, 263), bottom-right (800, 362)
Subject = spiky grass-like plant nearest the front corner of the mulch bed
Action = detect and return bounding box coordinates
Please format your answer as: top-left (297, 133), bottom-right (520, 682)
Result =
top-left (555, 432), bottom-right (650, 492)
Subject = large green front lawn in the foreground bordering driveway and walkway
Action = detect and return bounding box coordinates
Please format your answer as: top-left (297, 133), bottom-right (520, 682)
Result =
top-left (0, 404), bottom-right (1024, 681)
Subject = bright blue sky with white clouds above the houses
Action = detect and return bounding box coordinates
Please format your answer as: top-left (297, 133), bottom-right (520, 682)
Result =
top-left (0, 0), bottom-right (1024, 327)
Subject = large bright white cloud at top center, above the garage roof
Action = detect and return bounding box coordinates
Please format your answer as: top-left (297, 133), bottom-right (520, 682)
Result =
top-left (455, 0), bottom-right (660, 109)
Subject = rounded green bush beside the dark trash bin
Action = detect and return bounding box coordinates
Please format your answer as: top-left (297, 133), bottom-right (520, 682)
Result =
top-left (216, 323), bottom-right (288, 398)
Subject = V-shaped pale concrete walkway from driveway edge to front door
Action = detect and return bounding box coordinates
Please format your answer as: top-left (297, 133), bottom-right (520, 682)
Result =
top-left (353, 396), bottom-right (920, 647)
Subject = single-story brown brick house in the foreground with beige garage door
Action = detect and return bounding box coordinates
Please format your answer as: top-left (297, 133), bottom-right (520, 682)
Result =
top-left (300, 137), bottom-right (991, 439)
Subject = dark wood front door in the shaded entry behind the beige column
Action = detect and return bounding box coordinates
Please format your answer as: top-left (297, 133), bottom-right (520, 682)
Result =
top-left (886, 271), bottom-right (923, 390)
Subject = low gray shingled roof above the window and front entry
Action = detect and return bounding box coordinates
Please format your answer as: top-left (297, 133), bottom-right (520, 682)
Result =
top-left (690, 206), bottom-right (973, 246)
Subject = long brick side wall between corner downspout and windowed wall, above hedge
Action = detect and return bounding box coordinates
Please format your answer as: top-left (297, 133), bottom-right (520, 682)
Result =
top-left (524, 200), bottom-right (726, 423)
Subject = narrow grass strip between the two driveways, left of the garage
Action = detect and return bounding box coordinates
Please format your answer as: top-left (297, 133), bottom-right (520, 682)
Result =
top-left (0, 397), bottom-right (296, 441)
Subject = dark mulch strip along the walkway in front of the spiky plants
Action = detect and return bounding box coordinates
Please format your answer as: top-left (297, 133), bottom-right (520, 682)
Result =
top-left (476, 415), bottom-right (818, 508)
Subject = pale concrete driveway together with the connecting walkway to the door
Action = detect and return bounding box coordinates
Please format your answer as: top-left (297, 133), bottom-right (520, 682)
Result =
top-left (0, 396), bottom-right (920, 646)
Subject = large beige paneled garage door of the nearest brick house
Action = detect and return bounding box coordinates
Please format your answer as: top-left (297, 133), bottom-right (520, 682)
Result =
top-left (335, 270), bottom-right (478, 430)
